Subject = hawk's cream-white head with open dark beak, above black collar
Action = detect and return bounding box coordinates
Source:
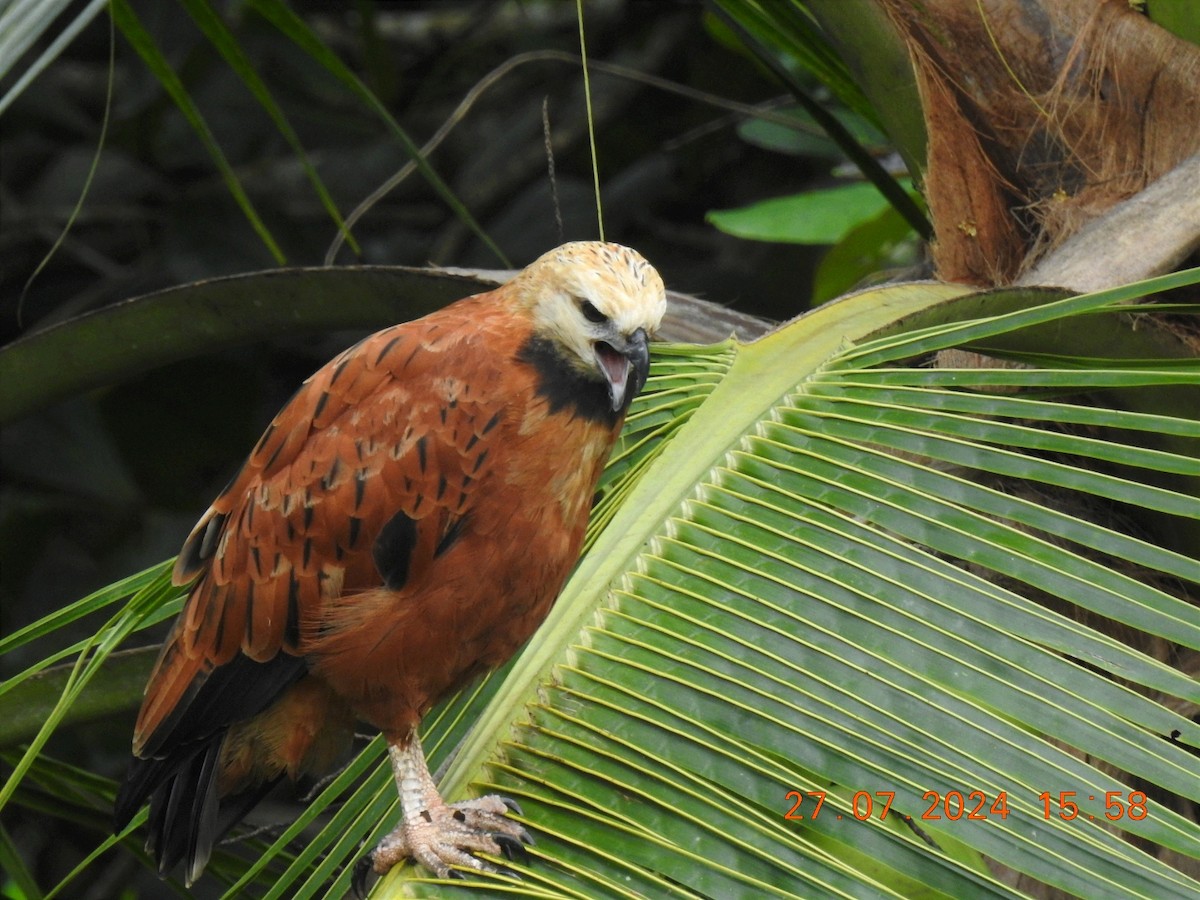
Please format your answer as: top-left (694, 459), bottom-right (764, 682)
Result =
top-left (512, 241), bottom-right (666, 414)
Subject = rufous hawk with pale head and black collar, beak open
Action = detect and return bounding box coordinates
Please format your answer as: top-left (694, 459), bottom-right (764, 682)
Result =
top-left (115, 242), bottom-right (666, 883)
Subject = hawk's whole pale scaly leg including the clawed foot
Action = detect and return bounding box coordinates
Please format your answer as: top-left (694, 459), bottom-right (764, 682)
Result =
top-left (371, 731), bottom-right (533, 878)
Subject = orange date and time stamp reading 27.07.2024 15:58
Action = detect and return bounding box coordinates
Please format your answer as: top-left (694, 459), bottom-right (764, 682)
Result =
top-left (784, 791), bottom-right (1150, 822)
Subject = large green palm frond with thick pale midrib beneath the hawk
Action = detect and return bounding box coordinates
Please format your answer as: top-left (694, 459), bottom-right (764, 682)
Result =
top-left (405, 272), bottom-right (1200, 896)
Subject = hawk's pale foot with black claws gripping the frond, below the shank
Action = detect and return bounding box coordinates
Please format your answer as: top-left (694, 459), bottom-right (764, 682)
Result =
top-left (355, 794), bottom-right (533, 887)
